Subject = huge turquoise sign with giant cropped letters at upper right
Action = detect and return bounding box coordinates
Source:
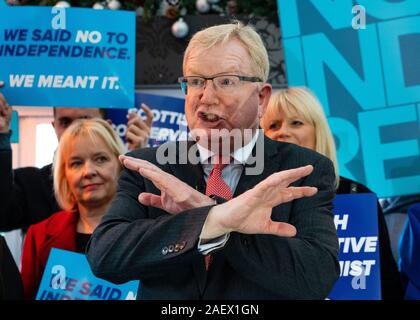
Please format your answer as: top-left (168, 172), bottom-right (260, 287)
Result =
top-left (277, 0), bottom-right (420, 197)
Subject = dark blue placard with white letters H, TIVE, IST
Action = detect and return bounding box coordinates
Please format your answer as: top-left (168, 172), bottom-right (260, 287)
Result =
top-left (328, 193), bottom-right (381, 300)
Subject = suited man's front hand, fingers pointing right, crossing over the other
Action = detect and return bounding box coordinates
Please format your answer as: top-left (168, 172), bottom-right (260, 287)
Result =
top-left (200, 165), bottom-right (318, 239)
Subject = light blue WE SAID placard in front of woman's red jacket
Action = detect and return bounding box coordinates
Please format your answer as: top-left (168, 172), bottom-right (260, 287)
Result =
top-left (36, 248), bottom-right (140, 300)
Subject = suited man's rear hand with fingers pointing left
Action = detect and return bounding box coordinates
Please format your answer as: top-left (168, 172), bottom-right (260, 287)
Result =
top-left (119, 155), bottom-right (214, 214)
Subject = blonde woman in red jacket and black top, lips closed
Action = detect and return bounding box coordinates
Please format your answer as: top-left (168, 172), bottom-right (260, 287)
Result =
top-left (22, 118), bottom-right (124, 299)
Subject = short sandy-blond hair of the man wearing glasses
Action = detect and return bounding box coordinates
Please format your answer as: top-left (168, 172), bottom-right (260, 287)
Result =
top-left (183, 21), bottom-right (270, 82)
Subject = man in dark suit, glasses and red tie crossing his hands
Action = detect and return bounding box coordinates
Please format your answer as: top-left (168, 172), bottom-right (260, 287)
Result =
top-left (87, 23), bottom-right (339, 299)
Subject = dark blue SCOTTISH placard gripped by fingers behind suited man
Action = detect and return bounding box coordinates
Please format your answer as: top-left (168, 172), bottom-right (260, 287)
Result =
top-left (107, 93), bottom-right (188, 147)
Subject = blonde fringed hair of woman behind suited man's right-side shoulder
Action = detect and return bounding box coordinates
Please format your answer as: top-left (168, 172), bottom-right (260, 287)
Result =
top-left (261, 87), bottom-right (340, 187)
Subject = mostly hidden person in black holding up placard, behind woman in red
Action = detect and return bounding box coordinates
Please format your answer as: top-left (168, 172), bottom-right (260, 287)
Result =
top-left (0, 85), bottom-right (153, 231)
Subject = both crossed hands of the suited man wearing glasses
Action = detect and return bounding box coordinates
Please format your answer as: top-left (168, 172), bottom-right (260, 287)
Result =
top-left (119, 155), bottom-right (318, 239)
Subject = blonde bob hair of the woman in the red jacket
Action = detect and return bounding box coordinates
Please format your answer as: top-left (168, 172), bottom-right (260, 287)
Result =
top-left (53, 118), bottom-right (125, 211)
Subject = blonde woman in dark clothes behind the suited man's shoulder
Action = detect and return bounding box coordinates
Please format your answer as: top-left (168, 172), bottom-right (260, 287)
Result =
top-left (261, 87), bottom-right (402, 300)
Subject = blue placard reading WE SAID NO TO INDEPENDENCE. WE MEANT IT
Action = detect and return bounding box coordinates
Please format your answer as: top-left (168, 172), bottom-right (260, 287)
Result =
top-left (0, 7), bottom-right (136, 108)
